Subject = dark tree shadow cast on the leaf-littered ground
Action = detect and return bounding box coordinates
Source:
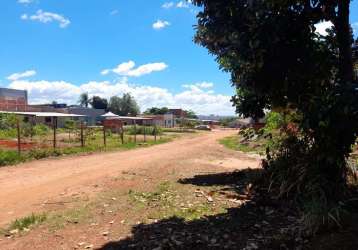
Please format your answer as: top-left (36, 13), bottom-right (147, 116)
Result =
top-left (100, 169), bottom-right (310, 250)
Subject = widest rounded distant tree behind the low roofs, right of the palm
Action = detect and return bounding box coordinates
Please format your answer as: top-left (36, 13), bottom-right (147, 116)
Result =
top-left (109, 93), bottom-right (140, 116)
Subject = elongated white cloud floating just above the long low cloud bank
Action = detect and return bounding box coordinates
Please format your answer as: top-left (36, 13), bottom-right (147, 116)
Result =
top-left (101, 61), bottom-right (168, 77)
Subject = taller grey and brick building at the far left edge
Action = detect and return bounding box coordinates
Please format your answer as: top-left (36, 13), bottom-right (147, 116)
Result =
top-left (0, 88), bottom-right (28, 111)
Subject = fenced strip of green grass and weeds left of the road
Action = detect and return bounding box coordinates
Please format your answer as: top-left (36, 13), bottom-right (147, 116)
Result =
top-left (0, 114), bottom-right (182, 167)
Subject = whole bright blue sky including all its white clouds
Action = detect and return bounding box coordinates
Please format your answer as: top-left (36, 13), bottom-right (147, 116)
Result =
top-left (0, 0), bottom-right (358, 115)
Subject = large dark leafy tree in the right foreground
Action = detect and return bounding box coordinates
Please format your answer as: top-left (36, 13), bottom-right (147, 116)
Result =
top-left (193, 0), bottom-right (358, 229)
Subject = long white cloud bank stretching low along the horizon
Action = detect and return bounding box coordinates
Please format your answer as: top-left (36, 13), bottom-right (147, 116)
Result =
top-left (8, 78), bottom-right (234, 115)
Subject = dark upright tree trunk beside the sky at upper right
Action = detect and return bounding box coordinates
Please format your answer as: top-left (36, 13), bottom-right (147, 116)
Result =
top-left (335, 0), bottom-right (353, 84)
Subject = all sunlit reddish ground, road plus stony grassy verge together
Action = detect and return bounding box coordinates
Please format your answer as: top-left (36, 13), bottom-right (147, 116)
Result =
top-left (0, 130), bottom-right (266, 249)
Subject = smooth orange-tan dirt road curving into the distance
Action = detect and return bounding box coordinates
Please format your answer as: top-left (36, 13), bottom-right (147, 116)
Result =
top-left (0, 130), bottom-right (258, 226)
